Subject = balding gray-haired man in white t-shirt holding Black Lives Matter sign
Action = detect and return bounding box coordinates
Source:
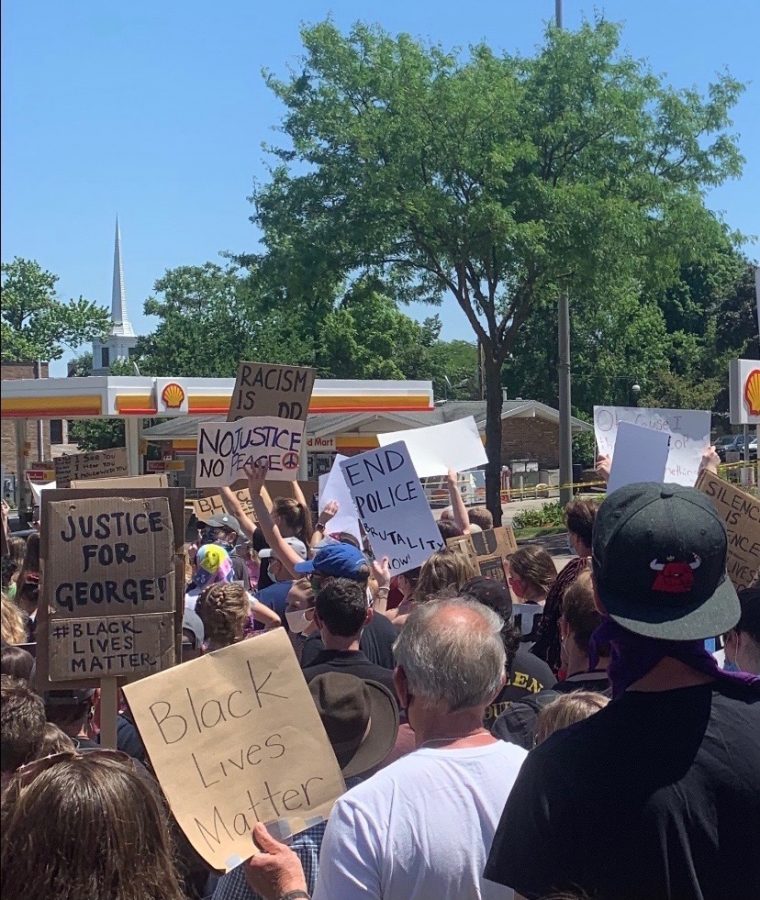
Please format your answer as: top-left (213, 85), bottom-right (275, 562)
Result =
top-left (246, 598), bottom-right (527, 900)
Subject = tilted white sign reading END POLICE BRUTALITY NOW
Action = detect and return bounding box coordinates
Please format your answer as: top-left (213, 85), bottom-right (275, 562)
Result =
top-left (340, 442), bottom-right (443, 574)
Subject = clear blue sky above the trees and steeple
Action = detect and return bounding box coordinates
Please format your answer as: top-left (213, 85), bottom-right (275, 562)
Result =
top-left (2, 0), bottom-right (760, 374)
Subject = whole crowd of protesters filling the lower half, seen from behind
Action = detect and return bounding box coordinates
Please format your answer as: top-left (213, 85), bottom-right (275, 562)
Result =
top-left (0, 451), bottom-right (760, 900)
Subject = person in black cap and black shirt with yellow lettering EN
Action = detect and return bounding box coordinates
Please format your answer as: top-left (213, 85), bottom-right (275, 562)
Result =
top-left (462, 575), bottom-right (556, 731)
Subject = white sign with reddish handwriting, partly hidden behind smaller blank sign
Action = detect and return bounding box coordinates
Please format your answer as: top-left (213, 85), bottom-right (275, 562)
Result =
top-left (594, 406), bottom-right (710, 487)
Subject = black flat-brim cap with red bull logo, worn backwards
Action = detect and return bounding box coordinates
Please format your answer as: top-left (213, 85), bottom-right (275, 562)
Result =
top-left (592, 482), bottom-right (740, 641)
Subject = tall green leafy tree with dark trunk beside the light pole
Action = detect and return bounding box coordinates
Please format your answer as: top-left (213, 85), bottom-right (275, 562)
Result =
top-left (248, 22), bottom-right (741, 522)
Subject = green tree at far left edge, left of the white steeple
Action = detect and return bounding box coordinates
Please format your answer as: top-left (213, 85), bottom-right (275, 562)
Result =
top-left (0, 256), bottom-right (110, 362)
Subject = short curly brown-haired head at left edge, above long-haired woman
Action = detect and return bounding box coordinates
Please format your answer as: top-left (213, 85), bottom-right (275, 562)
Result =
top-left (0, 675), bottom-right (45, 780)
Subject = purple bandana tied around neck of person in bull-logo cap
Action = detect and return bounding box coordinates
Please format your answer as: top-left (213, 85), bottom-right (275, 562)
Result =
top-left (588, 618), bottom-right (760, 697)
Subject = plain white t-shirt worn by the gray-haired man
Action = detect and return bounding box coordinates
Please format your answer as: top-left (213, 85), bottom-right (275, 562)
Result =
top-left (314, 741), bottom-right (527, 900)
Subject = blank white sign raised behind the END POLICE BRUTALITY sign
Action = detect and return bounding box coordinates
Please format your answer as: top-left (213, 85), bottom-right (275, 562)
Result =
top-left (377, 416), bottom-right (488, 478)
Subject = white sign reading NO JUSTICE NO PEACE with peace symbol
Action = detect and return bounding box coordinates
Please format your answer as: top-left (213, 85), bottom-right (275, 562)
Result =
top-left (195, 416), bottom-right (304, 487)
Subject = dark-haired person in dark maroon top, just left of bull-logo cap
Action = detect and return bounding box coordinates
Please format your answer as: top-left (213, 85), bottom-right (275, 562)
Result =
top-left (531, 500), bottom-right (599, 673)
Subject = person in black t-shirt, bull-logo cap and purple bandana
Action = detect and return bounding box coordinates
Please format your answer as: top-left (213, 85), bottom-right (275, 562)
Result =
top-left (485, 484), bottom-right (760, 900)
